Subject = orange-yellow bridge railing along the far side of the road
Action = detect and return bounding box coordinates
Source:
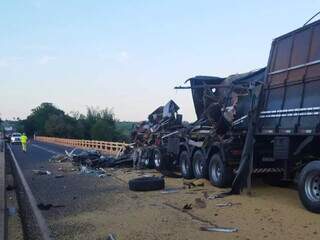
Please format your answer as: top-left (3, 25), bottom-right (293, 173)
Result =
top-left (34, 136), bottom-right (129, 155)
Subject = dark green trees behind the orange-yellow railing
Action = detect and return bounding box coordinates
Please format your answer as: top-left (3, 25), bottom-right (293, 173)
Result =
top-left (18, 103), bottom-right (134, 142)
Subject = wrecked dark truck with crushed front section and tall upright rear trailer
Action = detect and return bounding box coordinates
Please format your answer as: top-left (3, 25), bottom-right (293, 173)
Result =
top-left (176, 21), bottom-right (320, 213)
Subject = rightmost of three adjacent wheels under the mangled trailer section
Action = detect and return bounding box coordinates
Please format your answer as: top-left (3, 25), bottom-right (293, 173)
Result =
top-left (209, 154), bottom-right (233, 187)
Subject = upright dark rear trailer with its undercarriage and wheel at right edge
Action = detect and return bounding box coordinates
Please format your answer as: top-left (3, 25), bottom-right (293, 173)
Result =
top-left (249, 21), bottom-right (320, 212)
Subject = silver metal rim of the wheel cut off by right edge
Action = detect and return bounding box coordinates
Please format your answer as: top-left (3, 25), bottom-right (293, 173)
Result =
top-left (304, 172), bottom-right (320, 202)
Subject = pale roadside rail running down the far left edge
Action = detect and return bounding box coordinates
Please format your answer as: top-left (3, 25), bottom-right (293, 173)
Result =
top-left (0, 140), bottom-right (7, 240)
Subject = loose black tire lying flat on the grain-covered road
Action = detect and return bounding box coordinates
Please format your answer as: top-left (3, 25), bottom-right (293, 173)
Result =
top-left (129, 177), bottom-right (164, 191)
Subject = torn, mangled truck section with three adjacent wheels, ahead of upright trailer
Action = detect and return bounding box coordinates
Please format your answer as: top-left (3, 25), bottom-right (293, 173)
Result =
top-left (174, 68), bottom-right (265, 187)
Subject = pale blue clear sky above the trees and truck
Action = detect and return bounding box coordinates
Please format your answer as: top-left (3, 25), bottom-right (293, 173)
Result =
top-left (0, 0), bottom-right (320, 121)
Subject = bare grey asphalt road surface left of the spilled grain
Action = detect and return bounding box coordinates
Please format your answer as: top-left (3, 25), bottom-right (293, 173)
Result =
top-left (12, 142), bottom-right (127, 239)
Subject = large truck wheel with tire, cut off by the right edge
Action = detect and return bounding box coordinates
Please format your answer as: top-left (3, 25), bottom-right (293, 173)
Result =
top-left (298, 161), bottom-right (320, 213)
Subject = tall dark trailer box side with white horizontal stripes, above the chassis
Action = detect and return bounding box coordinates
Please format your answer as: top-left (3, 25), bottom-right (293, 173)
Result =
top-left (258, 21), bottom-right (320, 135)
